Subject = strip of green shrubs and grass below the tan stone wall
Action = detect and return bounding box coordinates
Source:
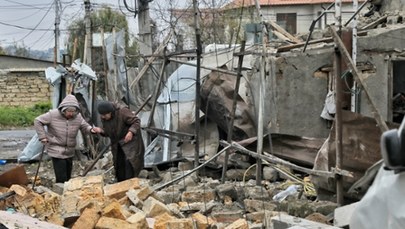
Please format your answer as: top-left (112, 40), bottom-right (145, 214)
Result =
top-left (0, 103), bottom-right (52, 129)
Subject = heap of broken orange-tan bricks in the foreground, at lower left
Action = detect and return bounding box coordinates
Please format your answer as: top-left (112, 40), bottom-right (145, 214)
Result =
top-left (0, 176), bottom-right (249, 229)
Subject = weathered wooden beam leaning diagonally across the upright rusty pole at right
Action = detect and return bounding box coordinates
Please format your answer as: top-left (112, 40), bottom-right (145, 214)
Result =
top-left (329, 26), bottom-right (389, 132)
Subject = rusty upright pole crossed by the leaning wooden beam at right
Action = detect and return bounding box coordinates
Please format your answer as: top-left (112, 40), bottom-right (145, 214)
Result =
top-left (335, 0), bottom-right (343, 206)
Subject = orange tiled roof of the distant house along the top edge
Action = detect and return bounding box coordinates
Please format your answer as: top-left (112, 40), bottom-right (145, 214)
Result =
top-left (231, 0), bottom-right (364, 7)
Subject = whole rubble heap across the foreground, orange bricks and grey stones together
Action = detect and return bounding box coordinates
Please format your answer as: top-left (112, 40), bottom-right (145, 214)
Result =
top-left (0, 160), bottom-right (337, 229)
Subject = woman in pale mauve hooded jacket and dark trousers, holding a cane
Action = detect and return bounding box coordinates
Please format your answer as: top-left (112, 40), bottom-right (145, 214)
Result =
top-left (34, 95), bottom-right (94, 183)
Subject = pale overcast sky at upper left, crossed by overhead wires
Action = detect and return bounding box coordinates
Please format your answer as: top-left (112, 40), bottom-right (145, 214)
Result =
top-left (0, 0), bottom-right (190, 50)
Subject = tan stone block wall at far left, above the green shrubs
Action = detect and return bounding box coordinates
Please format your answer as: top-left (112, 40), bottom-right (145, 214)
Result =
top-left (0, 72), bottom-right (52, 107)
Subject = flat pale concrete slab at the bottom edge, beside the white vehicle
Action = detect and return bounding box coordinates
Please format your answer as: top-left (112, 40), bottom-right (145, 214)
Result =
top-left (271, 214), bottom-right (341, 229)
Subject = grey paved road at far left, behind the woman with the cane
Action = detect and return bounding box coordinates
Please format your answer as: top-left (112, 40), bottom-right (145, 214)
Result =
top-left (0, 129), bottom-right (35, 159)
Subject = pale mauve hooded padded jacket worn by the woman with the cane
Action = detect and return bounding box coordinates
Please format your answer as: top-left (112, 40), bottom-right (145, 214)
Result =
top-left (34, 95), bottom-right (92, 158)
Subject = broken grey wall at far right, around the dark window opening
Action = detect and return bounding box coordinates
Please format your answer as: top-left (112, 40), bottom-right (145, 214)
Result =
top-left (357, 24), bottom-right (405, 121)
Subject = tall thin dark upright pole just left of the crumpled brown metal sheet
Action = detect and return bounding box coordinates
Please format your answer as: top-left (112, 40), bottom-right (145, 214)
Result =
top-left (193, 0), bottom-right (202, 172)
